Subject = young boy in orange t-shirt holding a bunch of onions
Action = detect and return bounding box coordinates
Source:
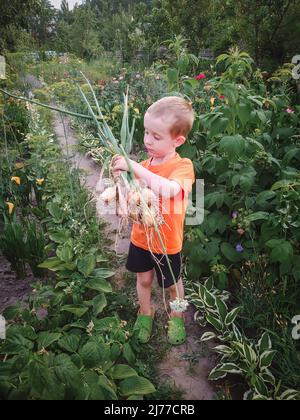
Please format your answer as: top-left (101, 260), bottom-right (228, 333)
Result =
top-left (112, 96), bottom-right (195, 345)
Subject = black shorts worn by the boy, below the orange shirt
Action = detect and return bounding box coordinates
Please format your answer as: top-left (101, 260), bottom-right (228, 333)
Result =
top-left (126, 243), bottom-right (182, 288)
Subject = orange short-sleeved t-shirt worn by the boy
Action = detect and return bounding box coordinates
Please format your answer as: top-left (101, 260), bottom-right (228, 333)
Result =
top-left (131, 153), bottom-right (195, 255)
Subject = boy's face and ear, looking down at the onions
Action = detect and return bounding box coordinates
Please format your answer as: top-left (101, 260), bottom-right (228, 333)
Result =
top-left (144, 112), bottom-right (185, 158)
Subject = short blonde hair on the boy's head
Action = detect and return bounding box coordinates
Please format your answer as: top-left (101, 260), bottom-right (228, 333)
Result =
top-left (147, 96), bottom-right (195, 138)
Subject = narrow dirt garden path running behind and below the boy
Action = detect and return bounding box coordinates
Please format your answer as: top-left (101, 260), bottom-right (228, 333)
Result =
top-left (54, 114), bottom-right (214, 400)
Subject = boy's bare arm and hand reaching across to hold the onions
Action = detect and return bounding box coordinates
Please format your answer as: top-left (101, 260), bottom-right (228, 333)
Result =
top-left (113, 156), bottom-right (181, 198)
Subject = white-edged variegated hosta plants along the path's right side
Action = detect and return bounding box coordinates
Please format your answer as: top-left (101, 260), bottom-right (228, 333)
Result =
top-left (189, 280), bottom-right (299, 400)
